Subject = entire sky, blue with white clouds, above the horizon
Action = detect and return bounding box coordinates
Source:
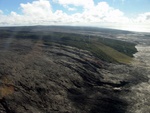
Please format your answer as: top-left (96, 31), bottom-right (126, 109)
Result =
top-left (0, 0), bottom-right (150, 32)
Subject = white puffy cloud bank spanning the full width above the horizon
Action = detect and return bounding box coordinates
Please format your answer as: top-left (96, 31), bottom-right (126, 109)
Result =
top-left (0, 0), bottom-right (150, 32)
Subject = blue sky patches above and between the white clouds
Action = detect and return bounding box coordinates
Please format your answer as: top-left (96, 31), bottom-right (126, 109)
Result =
top-left (0, 0), bottom-right (150, 16)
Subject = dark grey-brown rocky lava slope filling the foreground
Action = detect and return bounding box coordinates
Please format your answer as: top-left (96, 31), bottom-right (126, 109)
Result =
top-left (0, 26), bottom-right (149, 113)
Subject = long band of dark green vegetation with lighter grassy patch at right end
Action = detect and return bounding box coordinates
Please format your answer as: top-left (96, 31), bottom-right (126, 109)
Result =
top-left (0, 30), bottom-right (137, 64)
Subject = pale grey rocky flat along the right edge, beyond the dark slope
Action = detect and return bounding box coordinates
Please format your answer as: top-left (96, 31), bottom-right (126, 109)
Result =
top-left (115, 33), bottom-right (150, 113)
